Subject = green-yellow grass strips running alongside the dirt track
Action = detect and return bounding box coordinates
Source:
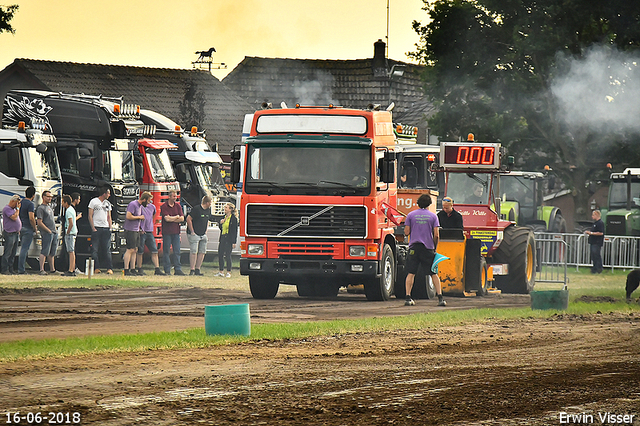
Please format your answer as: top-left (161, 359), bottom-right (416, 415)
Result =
top-left (0, 267), bottom-right (640, 362)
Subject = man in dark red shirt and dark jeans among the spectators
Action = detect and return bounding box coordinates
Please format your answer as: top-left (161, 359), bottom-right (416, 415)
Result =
top-left (160, 190), bottom-right (184, 275)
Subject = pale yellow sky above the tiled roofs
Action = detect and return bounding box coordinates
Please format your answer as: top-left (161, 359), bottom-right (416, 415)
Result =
top-left (0, 0), bottom-right (427, 79)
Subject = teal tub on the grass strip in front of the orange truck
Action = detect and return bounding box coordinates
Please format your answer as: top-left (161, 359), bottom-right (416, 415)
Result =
top-left (204, 303), bottom-right (251, 336)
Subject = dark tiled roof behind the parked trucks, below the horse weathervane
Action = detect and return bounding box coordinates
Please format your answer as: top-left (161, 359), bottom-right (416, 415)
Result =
top-left (0, 59), bottom-right (255, 154)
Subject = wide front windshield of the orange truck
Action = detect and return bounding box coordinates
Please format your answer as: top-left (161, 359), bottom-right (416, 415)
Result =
top-left (245, 144), bottom-right (372, 195)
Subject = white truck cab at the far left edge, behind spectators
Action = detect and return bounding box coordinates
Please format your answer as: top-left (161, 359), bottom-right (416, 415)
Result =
top-left (0, 120), bottom-right (62, 268)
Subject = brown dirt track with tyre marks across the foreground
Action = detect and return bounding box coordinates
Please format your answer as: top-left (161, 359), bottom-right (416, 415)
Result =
top-left (0, 287), bottom-right (640, 426)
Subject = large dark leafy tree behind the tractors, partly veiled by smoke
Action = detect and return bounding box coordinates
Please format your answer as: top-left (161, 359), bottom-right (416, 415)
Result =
top-left (410, 0), bottom-right (640, 220)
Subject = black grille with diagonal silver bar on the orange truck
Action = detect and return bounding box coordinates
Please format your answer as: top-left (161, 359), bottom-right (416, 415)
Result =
top-left (246, 204), bottom-right (367, 238)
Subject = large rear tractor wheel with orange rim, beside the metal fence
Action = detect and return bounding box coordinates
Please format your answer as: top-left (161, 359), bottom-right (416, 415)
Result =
top-left (493, 226), bottom-right (536, 294)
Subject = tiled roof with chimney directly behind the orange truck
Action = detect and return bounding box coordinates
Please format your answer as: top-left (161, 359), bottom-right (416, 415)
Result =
top-left (222, 41), bottom-right (432, 125)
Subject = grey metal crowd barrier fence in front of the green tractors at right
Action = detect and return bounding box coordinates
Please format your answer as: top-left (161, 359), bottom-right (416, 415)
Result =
top-left (535, 232), bottom-right (640, 270)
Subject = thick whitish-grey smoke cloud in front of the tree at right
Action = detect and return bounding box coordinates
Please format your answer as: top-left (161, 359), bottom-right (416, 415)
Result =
top-left (551, 46), bottom-right (640, 133)
